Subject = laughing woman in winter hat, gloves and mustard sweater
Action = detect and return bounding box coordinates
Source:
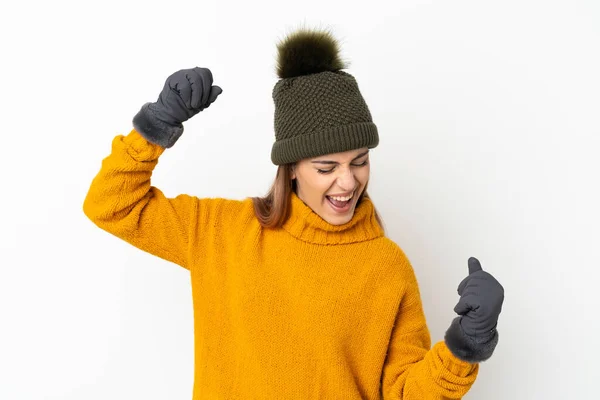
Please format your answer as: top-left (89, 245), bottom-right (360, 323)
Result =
top-left (84, 26), bottom-right (503, 400)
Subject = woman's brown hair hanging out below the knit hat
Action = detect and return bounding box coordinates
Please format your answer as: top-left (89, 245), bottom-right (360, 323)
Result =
top-left (252, 163), bottom-right (383, 229)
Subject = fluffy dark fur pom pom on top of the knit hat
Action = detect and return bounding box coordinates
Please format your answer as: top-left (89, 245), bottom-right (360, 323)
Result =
top-left (277, 28), bottom-right (347, 78)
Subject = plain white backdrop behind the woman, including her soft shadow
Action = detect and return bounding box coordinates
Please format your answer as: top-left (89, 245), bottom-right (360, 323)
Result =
top-left (0, 0), bottom-right (600, 400)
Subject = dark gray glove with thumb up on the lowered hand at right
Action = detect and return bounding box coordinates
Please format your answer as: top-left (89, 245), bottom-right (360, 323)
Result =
top-left (444, 257), bottom-right (504, 363)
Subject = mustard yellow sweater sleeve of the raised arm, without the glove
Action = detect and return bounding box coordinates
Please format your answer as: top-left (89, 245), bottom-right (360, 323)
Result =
top-left (83, 129), bottom-right (199, 269)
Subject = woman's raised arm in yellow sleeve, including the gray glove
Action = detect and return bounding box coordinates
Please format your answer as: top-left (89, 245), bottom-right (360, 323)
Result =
top-left (83, 67), bottom-right (222, 268)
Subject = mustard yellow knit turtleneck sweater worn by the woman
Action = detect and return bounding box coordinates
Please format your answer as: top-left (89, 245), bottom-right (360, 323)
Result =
top-left (83, 130), bottom-right (478, 400)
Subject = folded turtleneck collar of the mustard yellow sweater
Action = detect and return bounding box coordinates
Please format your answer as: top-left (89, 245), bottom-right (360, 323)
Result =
top-left (283, 192), bottom-right (384, 245)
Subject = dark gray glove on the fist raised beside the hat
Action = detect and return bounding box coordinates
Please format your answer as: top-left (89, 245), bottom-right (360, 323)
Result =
top-left (133, 67), bottom-right (223, 148)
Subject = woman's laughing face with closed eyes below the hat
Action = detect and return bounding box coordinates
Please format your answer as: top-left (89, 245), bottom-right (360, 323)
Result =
top-left (292, 147), bottom-right (371, 225)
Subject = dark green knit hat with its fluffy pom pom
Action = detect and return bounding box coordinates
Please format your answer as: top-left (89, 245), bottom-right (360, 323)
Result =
top-left (271, 29), bottom-right (379, 165)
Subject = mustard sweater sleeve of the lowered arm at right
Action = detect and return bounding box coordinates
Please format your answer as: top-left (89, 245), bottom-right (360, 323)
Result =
top-left (382, 266), bottom-right (479, 400)
